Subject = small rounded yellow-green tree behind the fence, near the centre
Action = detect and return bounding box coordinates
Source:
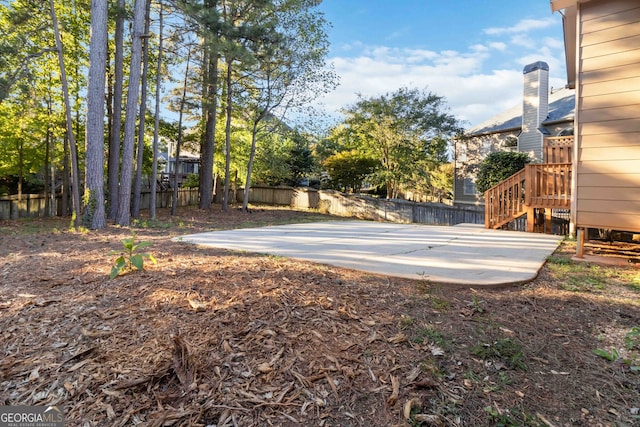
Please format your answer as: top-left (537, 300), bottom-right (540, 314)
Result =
top-left (322, 150), bottom-right (379, 192)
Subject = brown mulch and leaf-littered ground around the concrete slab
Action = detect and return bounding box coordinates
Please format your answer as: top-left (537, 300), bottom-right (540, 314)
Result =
top-left (0, 207), bottom-right (640, 427)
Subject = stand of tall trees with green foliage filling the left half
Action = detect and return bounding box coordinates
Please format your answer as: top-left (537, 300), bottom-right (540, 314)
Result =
top-left (0, 0), bottom-right (336, 228)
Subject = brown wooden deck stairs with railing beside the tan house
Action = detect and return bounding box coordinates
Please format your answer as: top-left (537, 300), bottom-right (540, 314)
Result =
top-left (484, 136), bottom-right (573, 231)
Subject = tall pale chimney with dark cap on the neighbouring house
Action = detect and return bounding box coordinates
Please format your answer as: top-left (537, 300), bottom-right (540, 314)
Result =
top-left (518, 61), bottom-right (549, 162)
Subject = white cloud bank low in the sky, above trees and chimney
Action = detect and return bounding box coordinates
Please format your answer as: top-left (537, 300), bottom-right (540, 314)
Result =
top-left (312, 17), bottom-right (565, 130)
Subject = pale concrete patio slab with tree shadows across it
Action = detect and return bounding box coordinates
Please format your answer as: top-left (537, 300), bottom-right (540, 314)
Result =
top-left (174, 221), bottom-right (561, 286)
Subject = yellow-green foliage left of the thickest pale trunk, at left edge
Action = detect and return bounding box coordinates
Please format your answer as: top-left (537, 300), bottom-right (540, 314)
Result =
top-left (0, 0), bottom-right (89, 221)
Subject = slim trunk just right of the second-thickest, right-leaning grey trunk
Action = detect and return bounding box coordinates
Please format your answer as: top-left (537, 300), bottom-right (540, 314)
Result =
top-left (131, 0), bottom-right (151, 218)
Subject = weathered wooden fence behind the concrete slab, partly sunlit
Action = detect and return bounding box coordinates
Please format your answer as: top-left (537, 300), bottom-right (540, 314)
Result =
top-left (237, 186), bottom-right (484, 225)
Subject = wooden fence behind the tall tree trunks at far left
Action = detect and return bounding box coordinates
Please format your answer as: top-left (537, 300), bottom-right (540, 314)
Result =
top-left (0, 188), bottom-right (198, 219)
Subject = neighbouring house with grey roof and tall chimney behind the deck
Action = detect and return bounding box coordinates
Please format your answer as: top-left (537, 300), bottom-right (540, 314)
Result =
top-left (454, 61), bottom-right (575, 205)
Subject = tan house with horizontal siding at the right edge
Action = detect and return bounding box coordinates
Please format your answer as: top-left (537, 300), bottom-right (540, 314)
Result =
top-left (551, 0), bottom-right (640, 251)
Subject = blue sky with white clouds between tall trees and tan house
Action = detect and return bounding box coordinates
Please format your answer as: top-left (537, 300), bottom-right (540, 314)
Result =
top-left (312, 0), bottom-right (566, 125)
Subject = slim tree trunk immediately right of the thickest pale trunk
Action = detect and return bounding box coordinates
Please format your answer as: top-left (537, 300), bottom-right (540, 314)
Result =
top-left (108, 0), bottom-right (125, 220)
